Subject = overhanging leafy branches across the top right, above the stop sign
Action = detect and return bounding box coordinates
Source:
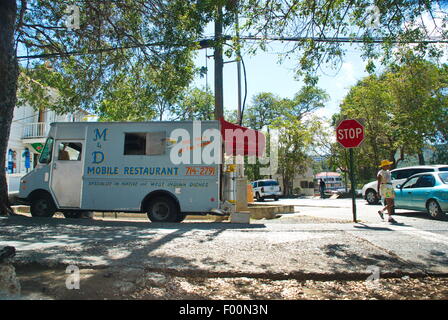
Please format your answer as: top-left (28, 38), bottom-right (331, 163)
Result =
top-left (240, 0), bottom-right (448, 77)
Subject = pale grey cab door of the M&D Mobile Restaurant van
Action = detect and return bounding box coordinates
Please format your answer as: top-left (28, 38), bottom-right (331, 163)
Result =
top-left (51, 140), bottom-right (84, 208)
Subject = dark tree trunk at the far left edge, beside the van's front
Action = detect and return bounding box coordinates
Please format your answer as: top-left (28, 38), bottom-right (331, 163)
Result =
top-left (0, 0), bottom-right (19, 215)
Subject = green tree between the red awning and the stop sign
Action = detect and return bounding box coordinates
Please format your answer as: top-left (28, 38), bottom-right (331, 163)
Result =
top-left (243, 86), bottom-right (328, 185)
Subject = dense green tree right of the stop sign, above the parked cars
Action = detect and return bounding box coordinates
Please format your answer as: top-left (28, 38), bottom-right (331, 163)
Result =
top-left (333, 55), bottom-right (448, 181)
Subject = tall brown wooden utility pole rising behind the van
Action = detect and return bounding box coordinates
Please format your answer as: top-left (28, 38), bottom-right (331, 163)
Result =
top-left (214, 4), bottom-right (224, 120)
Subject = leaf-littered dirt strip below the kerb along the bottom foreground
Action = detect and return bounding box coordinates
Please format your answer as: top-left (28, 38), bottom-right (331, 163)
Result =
top-left (17, 266), bottom-right (448, 300)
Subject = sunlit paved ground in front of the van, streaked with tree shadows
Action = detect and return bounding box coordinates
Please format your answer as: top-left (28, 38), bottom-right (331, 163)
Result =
top-left (0, 199), bottom-right (448, 278)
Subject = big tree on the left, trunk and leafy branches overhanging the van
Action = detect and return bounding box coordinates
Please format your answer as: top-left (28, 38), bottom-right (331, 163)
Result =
top-left (0, 0), bottom-right (216, 214)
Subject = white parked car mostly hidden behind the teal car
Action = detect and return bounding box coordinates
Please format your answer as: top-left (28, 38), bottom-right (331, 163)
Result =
top-left (362, 165), bottom-right (448, 204)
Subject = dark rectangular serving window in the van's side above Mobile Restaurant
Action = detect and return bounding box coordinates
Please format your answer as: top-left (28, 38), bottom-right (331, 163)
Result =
top-left (124, 132), bottom-right (166, 155)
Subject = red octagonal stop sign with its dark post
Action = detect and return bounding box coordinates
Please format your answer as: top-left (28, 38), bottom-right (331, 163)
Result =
top-left (336, 119), bottom-right (364, 222)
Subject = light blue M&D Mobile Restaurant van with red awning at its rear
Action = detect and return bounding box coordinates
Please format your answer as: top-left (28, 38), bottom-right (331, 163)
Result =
top-left (19, 119), bottom-right (264, 222)
